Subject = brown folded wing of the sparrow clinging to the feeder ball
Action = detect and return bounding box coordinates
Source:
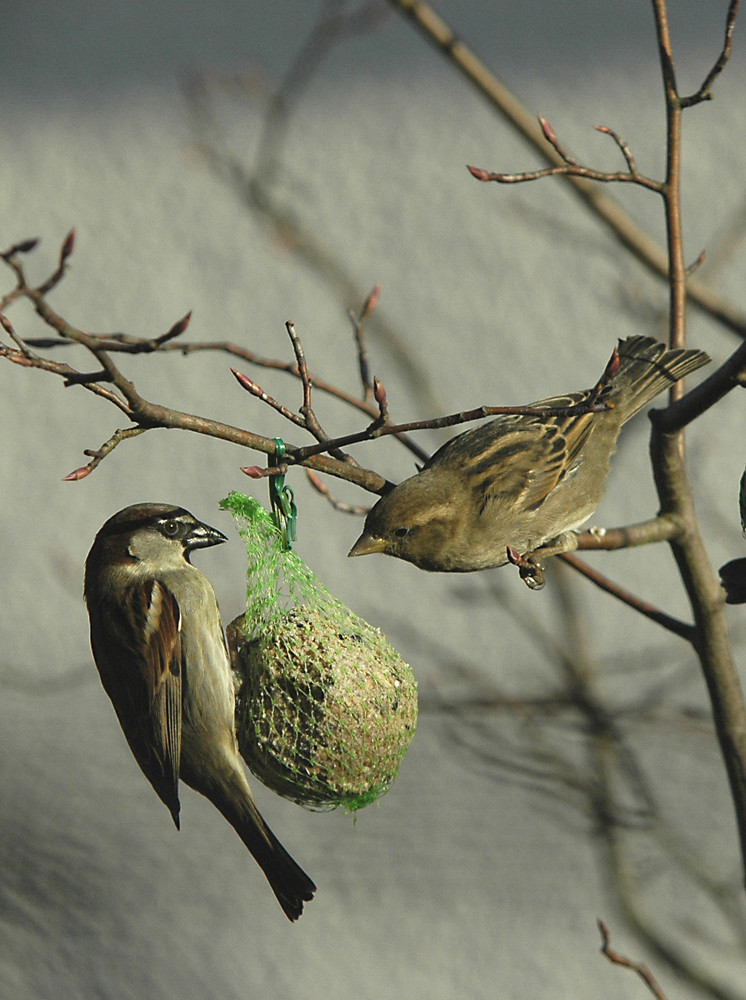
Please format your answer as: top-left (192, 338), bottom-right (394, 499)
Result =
top-left (91, 579), bottom-right (184, 826)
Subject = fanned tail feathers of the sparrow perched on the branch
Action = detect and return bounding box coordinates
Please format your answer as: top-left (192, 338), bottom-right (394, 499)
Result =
top-left (602, 337), bottom-right (710, 421)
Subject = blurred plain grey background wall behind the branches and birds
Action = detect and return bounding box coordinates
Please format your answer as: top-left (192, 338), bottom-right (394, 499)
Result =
top-left (0, 2), bottom-right (746, 1000)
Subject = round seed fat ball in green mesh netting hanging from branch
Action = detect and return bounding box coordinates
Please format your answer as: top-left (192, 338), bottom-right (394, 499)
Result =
top-left (220, 493), bottom-right (417, 811)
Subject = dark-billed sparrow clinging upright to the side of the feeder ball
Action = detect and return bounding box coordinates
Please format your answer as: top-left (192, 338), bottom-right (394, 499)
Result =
top-left (84, 503), bottom-right (316, 920)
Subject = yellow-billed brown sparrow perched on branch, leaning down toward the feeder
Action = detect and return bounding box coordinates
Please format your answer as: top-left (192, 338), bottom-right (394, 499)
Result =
top-left (349, 337), bottom-right (710, 585)
